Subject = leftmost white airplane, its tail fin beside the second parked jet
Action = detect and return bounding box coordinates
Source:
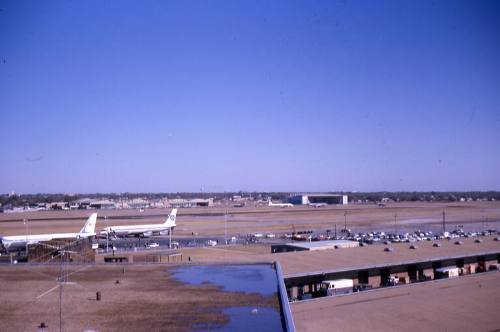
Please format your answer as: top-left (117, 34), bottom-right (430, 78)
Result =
top-left (0, 213), bottom-right (97, 251)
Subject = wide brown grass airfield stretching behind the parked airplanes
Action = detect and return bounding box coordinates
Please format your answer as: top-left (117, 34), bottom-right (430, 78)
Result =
top-left (0, 202), bottom-right (500, 236)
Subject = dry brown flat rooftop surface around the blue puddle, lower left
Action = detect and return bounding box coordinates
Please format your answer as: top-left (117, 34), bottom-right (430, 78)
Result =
top-left (0, 265), bottom-right (278, 331)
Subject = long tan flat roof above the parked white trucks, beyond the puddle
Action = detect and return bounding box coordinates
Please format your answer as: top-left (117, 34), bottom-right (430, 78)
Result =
top-left (176, 236), bottom-right (500, 278)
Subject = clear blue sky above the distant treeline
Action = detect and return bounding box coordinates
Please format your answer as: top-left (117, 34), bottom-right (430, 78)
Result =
top-left (0, 0), bottom-right (500, 193)
